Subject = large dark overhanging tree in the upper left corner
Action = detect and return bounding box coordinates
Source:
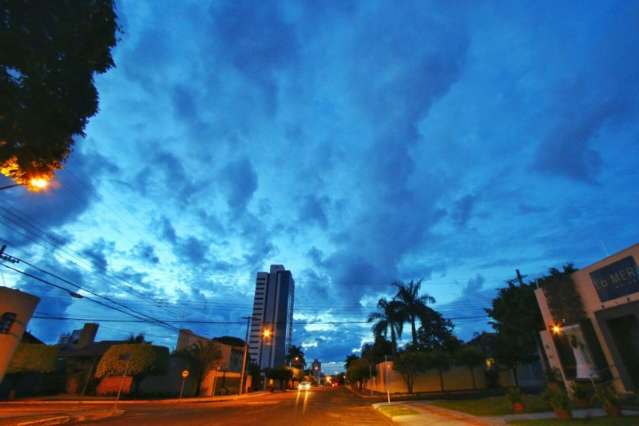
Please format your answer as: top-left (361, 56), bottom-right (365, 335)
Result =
top-left (0, 0), bottom-right (118, 183)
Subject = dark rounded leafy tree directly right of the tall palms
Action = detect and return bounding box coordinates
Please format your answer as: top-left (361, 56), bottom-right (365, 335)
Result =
top-left (413, 307), bottom-right (461, 352)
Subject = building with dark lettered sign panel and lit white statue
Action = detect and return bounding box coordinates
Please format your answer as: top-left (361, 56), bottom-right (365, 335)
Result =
top-left (535, 244), bottom-right (639, 393)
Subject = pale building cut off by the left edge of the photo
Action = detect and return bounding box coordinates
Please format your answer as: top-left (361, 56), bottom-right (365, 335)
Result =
top-left (0, 287), bottom-right (40, 382)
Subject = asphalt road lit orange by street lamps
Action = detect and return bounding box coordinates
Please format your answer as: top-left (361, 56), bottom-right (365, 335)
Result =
top-left (0, 388), bottom-right (392, 426)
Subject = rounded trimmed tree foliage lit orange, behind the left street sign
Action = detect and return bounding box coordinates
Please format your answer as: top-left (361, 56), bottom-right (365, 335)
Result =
top-left (95, 343), bottom-right (169, 378)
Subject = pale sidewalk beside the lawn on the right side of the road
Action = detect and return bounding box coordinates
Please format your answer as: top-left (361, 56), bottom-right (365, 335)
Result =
top-left (373, 401), bottom-right (639, 426)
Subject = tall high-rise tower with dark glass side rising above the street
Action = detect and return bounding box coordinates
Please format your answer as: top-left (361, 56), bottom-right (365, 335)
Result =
top-left (249, 265), bottom-right (295, 368)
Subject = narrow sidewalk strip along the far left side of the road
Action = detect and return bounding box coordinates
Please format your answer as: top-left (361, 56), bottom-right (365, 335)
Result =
top-left (0, 391), bottom-right (270, 408)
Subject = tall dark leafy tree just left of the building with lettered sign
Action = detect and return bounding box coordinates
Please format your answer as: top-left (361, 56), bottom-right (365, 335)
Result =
top-left (486, 281), bottom-right (544, 386)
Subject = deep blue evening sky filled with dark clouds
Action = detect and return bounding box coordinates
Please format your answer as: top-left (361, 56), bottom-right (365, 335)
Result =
top-left (0, 0), bottom-right (639, 372)
